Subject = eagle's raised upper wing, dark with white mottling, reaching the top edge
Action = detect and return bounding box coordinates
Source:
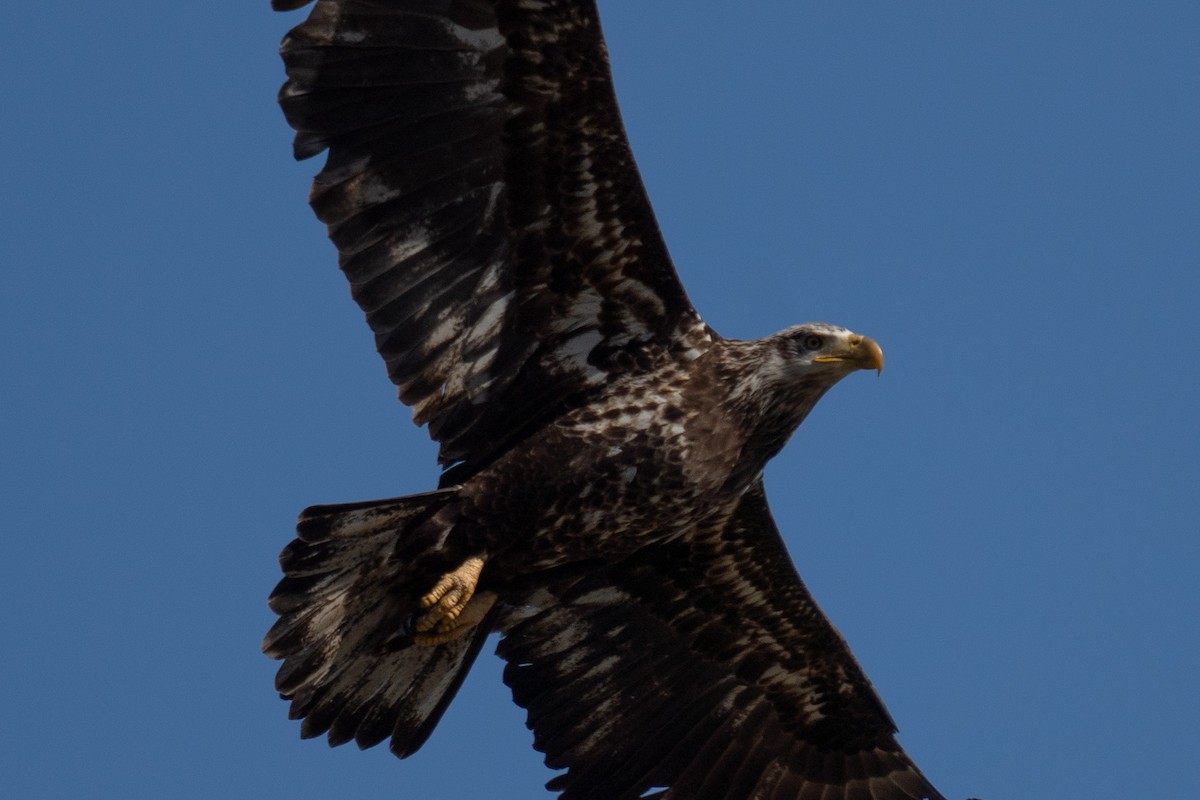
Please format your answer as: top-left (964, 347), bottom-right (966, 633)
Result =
top-left (274, 0), bottom-right (710, 473)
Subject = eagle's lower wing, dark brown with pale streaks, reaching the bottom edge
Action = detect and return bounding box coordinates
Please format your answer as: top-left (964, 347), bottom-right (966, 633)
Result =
top-left (499, 482), bottom-right (942, 800)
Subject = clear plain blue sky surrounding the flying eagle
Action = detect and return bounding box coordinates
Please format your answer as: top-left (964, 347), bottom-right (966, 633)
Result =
top-left (0, 0), bottom-right (1200, 800)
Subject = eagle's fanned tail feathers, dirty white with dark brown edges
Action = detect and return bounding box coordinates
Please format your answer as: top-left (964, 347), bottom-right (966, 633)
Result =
top-left (263, 489), bottom-right (491, 758)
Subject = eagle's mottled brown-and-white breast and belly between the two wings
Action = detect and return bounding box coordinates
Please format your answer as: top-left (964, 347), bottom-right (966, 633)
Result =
top-left (463, 345), bottom-right (749, 570)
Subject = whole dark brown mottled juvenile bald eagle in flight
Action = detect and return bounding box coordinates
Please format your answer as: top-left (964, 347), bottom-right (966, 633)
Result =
top-left (264, 0), bottom-right (941, 800)
